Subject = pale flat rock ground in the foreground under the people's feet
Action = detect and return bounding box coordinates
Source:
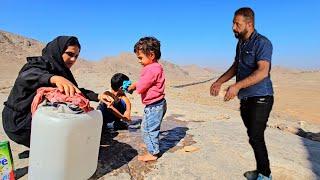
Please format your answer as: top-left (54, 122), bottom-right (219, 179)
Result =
top-left (0, 76), bottom-right (320, 180)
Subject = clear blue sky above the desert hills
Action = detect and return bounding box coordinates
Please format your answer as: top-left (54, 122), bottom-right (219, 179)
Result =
top-left (0, 0), bottom-right (320, 69)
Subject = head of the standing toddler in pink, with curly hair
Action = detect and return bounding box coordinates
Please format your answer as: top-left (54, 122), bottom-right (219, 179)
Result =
top-left (134, 37), bottom-right (161, 66)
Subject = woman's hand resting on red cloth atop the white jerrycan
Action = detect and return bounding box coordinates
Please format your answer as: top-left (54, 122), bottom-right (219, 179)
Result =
top-left (50, 76), bottom-right (81, 96)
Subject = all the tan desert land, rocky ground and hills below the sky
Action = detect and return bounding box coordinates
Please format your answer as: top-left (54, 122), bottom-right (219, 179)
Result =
top-left (0, 31), bottom-right (320, 179)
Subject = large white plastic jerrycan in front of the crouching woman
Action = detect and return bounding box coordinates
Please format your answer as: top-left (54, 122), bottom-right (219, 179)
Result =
top-left (28, 106), bottom-right (103, 180)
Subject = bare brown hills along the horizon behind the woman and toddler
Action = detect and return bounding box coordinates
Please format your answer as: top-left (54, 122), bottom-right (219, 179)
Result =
top-left (0, 30), bottom-right (212, 83)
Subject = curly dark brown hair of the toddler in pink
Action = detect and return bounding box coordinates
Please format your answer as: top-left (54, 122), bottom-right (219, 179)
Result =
top-left (134, 37), bottom-right (161, 60)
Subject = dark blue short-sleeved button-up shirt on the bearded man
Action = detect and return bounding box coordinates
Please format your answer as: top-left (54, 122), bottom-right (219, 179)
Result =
top-left (235, 30), bottom-right (273, 99)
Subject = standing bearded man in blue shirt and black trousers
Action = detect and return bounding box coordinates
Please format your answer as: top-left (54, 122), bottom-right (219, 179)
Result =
top-left (210, 7), bottom-right (273, 179)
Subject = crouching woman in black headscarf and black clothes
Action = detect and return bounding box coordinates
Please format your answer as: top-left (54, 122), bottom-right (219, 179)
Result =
top-left (2, 36), bottom-right (112, 147)
